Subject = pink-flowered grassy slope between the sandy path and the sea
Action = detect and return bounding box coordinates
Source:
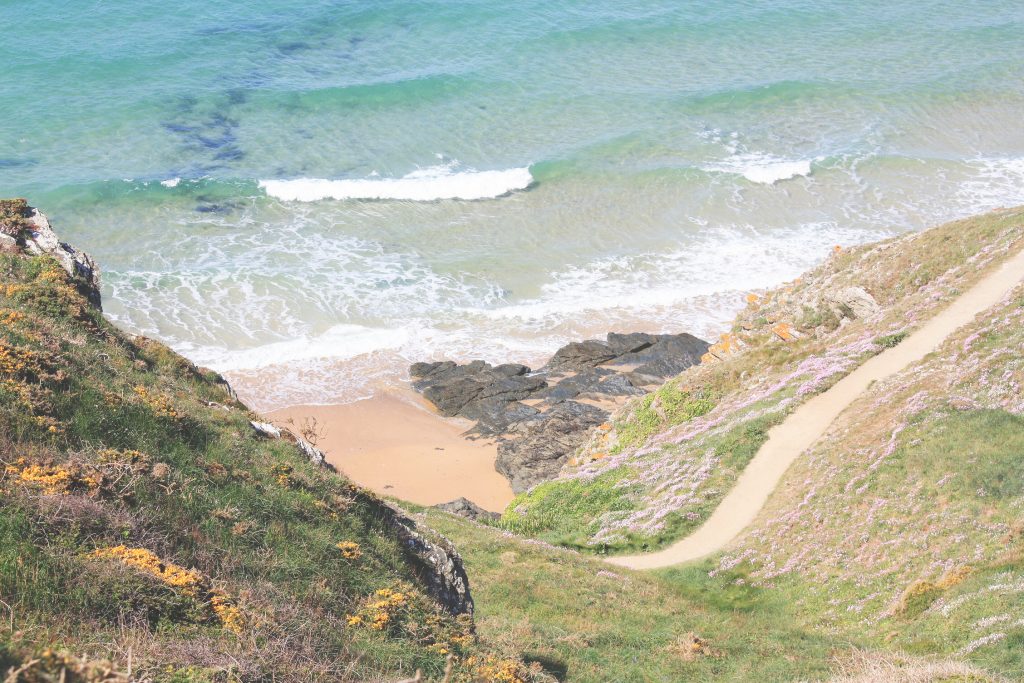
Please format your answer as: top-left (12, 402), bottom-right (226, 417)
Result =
top-left (502, 209), bottom-right (1024, 553)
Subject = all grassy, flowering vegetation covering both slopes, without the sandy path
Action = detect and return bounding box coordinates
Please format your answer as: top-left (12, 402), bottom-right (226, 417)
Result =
top-left (0, 203), bottom-right (1024, 683)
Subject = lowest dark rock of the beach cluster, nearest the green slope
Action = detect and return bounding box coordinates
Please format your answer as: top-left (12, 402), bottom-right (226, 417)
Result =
top-left (495, 400), bottom-right (608, 494)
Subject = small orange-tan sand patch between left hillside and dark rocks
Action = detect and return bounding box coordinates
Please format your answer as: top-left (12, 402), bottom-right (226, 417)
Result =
top-left (266, 392), bottom-right (513, 512)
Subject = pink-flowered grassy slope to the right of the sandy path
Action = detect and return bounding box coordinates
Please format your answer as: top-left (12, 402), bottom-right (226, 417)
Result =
top-left (719, 260), bottom-right (1024, 680)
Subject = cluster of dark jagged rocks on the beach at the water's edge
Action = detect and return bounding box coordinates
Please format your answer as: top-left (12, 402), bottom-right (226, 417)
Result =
top-left (410, 333), bottom-right (709, 493)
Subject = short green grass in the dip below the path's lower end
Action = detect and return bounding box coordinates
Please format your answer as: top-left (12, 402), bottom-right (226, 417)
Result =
top-left (428, 511), bottom-right (855, 683)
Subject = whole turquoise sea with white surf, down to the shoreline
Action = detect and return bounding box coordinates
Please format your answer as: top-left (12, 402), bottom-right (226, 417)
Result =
top-left (0, 0), bottom-right (1024, 408)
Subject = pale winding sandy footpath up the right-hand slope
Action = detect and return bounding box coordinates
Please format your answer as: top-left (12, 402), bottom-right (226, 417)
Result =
top-left (607, 245), bottom-right (1024, 569)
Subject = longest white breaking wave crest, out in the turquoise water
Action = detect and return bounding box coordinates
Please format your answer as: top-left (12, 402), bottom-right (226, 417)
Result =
top-left (259, 164), bottom-right (534, 202)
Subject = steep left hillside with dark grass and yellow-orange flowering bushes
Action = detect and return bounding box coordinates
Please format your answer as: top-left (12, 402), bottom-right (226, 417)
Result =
top-left (0, 202), bottom-right (544, 681)
